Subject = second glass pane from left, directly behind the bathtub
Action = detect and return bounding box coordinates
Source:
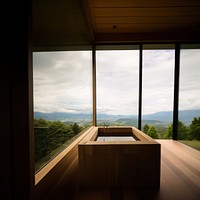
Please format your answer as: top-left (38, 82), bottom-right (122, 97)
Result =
top-left (96, 50), bottom-right (139, 126)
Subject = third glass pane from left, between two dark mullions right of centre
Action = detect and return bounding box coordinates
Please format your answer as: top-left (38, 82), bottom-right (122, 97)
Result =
top-left (142, 49), bottom-right (175, 139)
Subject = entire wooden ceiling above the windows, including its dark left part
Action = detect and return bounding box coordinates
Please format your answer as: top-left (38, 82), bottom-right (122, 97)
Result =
top-left (33, 0), bottom-right (200, 48)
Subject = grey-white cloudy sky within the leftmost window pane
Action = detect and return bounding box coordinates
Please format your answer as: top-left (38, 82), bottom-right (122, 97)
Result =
top-left (33, 51), bottom-right (92, 113)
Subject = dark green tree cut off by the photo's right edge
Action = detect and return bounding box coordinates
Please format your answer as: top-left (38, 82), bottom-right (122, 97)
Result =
top-left (189, 117), bottom-right (200, 140)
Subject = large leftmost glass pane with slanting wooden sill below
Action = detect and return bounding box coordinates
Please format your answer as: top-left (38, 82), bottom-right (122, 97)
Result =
top-left (33, 51), bottom-right (92, 171)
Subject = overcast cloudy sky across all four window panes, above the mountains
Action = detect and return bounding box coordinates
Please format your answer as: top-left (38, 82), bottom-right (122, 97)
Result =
top-left (33, 50), bottom-right (200, 115)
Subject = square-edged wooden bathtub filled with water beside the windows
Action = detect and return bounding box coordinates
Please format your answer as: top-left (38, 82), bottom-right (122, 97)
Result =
top-left (78, 127), bottom-right (160, 188)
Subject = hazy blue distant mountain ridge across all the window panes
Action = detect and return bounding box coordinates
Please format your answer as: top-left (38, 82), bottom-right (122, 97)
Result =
top-left (34, 110), bottom-right (200, 123)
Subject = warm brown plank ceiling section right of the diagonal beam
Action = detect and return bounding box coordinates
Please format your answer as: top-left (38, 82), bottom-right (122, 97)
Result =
top-left (87, 0), bottom-right (200, 40)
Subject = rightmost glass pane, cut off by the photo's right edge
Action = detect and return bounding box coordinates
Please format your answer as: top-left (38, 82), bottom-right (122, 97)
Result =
top-left (178, 49), bottom-right (200, 150)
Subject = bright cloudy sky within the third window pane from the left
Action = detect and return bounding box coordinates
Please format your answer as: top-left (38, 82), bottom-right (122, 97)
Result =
top-left (143, 50), bottom-right (175, 114)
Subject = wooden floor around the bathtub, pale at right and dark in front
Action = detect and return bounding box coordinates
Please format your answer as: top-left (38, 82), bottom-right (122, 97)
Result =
top-left (49, 140), bottom-right (200, 200)
